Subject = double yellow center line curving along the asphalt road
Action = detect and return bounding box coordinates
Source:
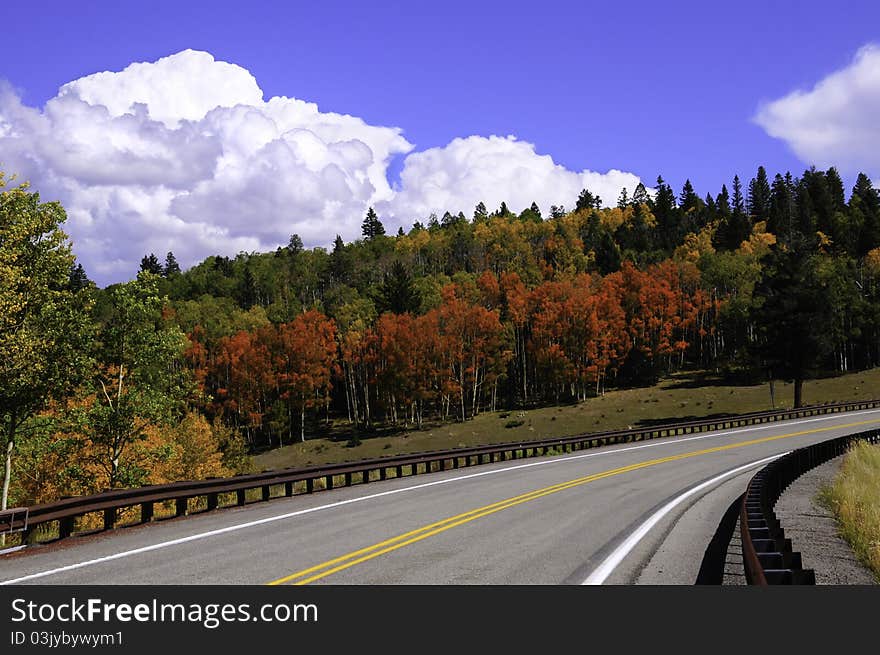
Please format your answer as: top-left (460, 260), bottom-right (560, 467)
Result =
top-left (268, 419), bottom-right (880, 585)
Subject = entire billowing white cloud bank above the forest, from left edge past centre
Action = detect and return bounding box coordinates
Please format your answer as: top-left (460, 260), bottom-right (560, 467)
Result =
top-left (0, 50), bottom-right (638, 285)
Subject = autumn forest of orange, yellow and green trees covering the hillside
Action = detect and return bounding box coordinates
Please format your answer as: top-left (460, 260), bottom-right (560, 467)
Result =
top-left (0, 167), bottom-right (880, 508)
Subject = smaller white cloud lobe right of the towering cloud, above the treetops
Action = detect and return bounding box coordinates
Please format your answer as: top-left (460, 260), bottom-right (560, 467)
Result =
top-left (379, 136), bottom-right (639, 223)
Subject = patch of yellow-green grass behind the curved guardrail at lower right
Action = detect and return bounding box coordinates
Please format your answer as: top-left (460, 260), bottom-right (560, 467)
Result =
top-left (819, 441), bottom-right (880, 582)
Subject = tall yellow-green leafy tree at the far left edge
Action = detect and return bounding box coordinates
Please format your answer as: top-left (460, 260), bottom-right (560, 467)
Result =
top-left (0, 174), bottom-right (90, 509)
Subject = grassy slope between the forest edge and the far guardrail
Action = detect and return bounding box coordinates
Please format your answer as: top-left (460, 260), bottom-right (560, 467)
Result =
top-left (253, 369), bottom-right (880, 471)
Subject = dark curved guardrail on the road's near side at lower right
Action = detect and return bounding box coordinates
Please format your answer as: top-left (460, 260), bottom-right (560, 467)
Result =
top-left (739, 429), bottom-right (880, 586)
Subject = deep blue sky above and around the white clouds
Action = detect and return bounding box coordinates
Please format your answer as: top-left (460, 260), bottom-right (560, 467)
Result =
top-left (0, 0), bottom-right (880, 280)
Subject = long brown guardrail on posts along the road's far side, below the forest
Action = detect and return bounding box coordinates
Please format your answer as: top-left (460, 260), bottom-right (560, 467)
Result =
top-left (9, 400), bottom-right (880, 543)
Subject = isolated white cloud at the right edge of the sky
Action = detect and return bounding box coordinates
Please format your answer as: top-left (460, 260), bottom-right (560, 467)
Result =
top-left (754, 44), bottom-right (880, 176)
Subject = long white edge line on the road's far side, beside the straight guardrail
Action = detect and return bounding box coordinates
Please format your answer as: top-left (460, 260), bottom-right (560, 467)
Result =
top-left (0, 410), bottom-right (880, 586)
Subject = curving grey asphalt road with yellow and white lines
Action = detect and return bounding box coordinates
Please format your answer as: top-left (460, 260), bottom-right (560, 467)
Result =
top-left (0, 410), bottom-right (880, 585)
